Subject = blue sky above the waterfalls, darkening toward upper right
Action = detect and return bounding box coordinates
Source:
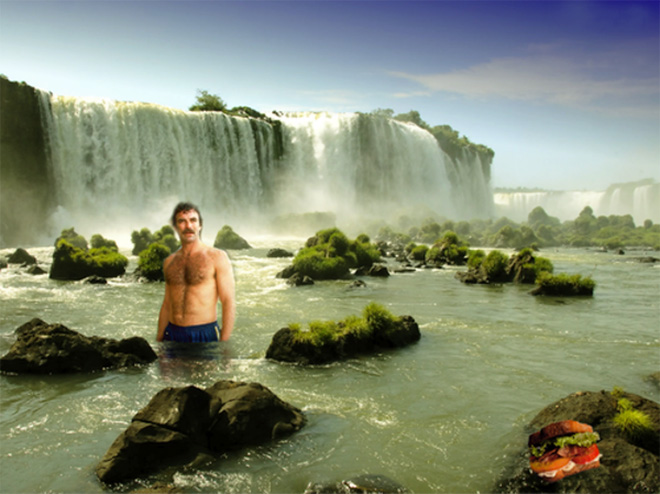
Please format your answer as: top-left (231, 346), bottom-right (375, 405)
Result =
top-left (0, 0), bottom-right (660, 190)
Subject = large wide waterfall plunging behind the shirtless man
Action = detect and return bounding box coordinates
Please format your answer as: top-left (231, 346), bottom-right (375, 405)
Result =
top-left (40, 96), bottom-right (493, 240)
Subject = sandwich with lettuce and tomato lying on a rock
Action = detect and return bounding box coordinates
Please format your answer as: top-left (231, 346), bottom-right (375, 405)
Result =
top-left (527, 420), bottom-right (602, 482)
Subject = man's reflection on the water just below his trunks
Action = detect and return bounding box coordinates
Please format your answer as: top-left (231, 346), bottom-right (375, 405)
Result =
top-left (157, 341), bottom-right (234, 383)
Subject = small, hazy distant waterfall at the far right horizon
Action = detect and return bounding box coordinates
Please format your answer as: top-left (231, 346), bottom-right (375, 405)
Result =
top-left (494, 179), bottom-right (660, 226)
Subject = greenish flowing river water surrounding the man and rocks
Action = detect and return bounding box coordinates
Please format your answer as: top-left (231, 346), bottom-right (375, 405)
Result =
top-left (0, 243), bottom-right (660, 493)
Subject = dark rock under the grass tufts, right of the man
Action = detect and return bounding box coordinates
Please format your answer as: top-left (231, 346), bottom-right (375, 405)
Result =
top-left (266, 316), bottom-right (421, 365)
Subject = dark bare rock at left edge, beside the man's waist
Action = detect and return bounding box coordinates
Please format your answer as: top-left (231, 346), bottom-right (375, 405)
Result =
top-left (0, 318), bottom-right (157, 374)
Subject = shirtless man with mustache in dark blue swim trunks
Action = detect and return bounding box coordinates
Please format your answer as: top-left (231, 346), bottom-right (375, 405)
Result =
top-left (156, 202), bottom-right (236, 343)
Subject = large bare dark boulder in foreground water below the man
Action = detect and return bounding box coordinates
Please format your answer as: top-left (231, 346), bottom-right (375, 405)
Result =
top-left (96, 381), bottom-right (305, 483)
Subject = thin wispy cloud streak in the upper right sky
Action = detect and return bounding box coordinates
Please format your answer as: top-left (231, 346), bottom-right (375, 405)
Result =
top-left (390, 45), bottom-right (660, 116)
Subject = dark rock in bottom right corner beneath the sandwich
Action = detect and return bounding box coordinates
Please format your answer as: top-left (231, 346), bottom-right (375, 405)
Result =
top-left (496, 391), bottom-right (660, 493)
